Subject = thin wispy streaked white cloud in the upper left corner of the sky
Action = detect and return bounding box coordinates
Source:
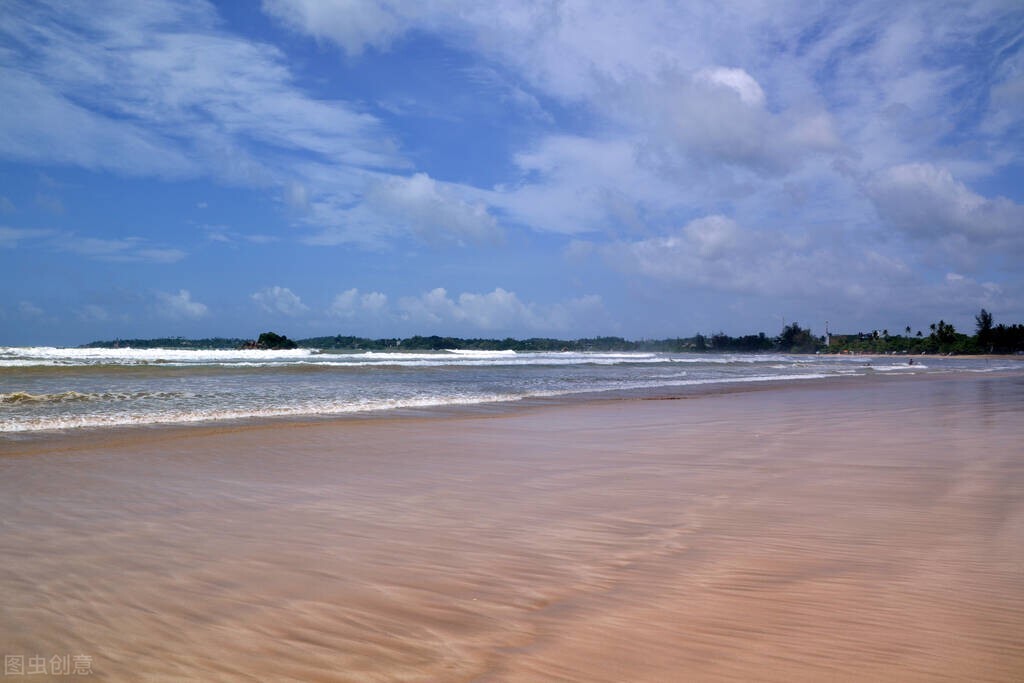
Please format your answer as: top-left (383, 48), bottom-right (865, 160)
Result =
top-left (0, 0), bottom-right (407, 201)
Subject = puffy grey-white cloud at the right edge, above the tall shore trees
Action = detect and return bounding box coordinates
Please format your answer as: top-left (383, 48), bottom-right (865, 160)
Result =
top-left (866, 164), bottom-right (1024, 243)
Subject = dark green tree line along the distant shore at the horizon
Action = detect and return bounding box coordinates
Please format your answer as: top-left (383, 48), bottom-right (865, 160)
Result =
top-left (82, 308), bottom-right (1024, 355)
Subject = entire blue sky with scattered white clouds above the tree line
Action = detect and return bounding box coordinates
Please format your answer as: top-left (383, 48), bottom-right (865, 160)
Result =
top-left (0, 0), bottom-right (1024, 345)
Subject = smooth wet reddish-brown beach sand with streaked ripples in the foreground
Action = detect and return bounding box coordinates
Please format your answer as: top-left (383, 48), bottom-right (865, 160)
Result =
top-left (0, 376), bottom-right (1024, 682)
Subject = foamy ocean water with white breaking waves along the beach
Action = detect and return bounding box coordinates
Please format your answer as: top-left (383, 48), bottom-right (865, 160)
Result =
top-left (0, 347), bottom-right (1024, 437)
